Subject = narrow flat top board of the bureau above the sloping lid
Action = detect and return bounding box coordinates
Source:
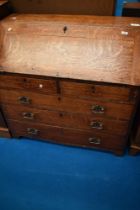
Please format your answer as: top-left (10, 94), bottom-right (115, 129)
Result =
top-left (1, 13), bottom-right (140, 27)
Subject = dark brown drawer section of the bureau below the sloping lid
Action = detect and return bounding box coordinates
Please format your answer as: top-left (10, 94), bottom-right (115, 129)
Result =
top-left (0, 73), bottom-right (139, 154)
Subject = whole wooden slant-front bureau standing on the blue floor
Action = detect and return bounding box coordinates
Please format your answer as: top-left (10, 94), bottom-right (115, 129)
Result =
top-left (0, 14), bottom-right (140, 154)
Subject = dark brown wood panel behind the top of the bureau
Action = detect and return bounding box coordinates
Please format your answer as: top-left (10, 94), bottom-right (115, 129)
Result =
top-left (10, 0), bottom-right (115, 15)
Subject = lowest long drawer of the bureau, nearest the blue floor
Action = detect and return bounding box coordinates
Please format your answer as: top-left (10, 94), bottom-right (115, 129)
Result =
top-left (9, 120), bottom-right (126, 149)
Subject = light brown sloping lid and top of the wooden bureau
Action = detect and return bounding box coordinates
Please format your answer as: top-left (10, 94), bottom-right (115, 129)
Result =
top-left (0, 14), bottom-right (140, 86)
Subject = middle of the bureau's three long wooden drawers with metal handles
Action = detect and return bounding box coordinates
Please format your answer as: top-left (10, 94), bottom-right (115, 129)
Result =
top-left (3, 105), bottom-right (129, 135)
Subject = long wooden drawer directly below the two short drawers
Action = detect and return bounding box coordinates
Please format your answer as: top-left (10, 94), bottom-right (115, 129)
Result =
top-left (0, 90), bottom-right (134, 120)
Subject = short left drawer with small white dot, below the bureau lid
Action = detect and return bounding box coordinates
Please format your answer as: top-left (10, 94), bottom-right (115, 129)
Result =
top-left (0, 75), bottom-right (57, 94)
